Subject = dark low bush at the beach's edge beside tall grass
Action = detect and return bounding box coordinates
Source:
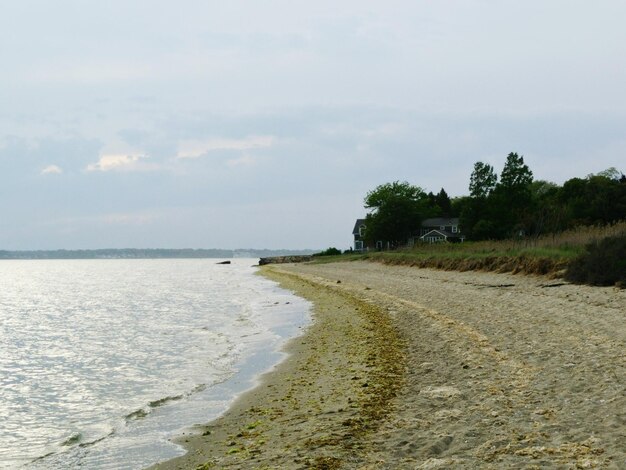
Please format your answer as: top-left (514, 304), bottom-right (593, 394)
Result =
top-left (565, 234), bottom-right (626, 288)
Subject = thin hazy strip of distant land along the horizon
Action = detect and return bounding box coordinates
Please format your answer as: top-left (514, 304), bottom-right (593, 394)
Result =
top-left (0, 248), bottom-right (319, 260)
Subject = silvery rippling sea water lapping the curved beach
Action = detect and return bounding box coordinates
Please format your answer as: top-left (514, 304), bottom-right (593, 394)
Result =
top-left (0, 259), bottom-right (310, 469)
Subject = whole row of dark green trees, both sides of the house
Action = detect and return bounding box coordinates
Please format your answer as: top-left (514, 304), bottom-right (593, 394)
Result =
top-left (364, 152), bottom-right (626, 247)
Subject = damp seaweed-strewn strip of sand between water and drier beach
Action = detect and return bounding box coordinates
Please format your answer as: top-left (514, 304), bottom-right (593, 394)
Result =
top-left (149, 266), bottom-right (404, 470)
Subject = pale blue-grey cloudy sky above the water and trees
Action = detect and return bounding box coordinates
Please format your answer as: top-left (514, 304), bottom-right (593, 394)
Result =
top-left (0, 0), bottom-right (626, 250)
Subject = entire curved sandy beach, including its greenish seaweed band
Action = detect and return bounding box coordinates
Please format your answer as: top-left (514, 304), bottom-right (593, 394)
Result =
top-left (149, 262), bottom-right (626, 469)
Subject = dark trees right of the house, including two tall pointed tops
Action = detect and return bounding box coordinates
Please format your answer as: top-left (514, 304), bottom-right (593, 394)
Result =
top-left (453, 153), bottom-right (626, 240)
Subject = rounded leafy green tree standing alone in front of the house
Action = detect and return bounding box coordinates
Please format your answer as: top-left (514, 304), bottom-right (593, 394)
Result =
top-left (364, 181), bottom-right (430, 246)
